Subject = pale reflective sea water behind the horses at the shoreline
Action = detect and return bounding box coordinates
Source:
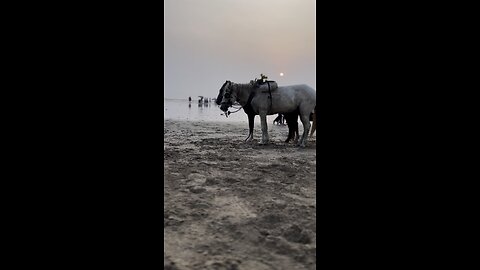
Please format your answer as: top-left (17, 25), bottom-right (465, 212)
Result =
top-left (163, 98), bottom-right (277, 126)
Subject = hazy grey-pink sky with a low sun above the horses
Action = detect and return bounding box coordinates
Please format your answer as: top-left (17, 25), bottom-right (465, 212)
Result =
top-left (164, 0), bottom-right (316, 99)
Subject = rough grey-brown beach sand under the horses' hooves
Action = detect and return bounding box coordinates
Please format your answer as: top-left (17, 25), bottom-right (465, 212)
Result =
top-left (163, 120), bottom-right (316, 270)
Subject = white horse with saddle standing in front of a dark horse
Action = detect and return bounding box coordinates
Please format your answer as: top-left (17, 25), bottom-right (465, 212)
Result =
top-left (220, 82), bottom-right (317, 147)
